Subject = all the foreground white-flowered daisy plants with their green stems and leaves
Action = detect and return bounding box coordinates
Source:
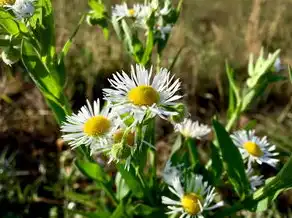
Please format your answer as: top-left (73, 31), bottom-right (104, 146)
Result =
top-left (0, 0), bottom-right (292, 218)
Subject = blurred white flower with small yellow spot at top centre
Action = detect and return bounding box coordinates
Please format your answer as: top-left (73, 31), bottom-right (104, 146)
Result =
top-left (112, 3), bottom-right (151, 20)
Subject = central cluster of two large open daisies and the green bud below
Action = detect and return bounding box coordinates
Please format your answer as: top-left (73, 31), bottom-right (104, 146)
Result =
top-left (61, 65), bottom-right (182, 167)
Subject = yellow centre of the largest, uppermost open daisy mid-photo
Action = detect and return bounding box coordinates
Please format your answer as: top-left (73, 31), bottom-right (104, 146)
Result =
top-left (128, 85), bottom-right (159, 106)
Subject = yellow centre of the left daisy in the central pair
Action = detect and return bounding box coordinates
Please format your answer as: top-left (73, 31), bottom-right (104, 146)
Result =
top-left (83, 115), bottom-right (111, 136)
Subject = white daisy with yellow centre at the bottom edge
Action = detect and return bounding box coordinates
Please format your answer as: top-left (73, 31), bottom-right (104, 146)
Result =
top-left (162, 174), bottom-right (223, 218)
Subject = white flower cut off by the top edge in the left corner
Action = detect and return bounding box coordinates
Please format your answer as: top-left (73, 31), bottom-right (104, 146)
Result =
top-left (4, 0), bottom-right (36, 20)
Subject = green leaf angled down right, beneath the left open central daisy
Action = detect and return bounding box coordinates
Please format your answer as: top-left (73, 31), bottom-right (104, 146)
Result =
top-left (75, 159), bottom-right (110, 184)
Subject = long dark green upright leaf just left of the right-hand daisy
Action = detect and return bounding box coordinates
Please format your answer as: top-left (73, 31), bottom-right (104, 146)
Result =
top-left (213, 120), bottom-right (250, 199)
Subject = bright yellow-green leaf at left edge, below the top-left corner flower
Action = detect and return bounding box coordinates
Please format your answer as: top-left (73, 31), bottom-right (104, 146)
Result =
top-left (0, 8), bottom-right (28, 36)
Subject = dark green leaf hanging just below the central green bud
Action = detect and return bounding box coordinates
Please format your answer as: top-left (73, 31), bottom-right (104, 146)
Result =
top-left (117, 164), bottom-right (144, 198)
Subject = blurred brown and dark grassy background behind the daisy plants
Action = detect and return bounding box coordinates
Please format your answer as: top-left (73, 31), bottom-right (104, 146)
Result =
top-left (0, 0), bottom-right (292, 217)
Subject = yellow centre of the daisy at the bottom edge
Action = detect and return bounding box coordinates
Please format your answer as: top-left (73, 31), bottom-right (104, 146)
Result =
top-left (181, 193), bottom-right (202, 215)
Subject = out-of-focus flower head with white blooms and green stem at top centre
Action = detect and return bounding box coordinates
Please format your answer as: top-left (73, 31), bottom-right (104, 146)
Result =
top-left (88, 0), bottom-right (182, 65)
